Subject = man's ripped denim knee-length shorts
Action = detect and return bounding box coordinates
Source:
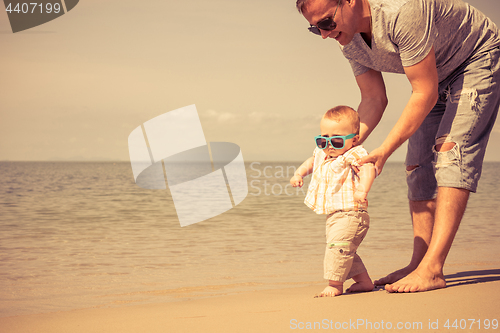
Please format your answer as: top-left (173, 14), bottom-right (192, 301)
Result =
top-left (405, 48), bottom-right (500, 201)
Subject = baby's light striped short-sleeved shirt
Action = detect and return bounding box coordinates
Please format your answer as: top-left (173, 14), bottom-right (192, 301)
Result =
top-left (304, 146), bottom-right (368, 214)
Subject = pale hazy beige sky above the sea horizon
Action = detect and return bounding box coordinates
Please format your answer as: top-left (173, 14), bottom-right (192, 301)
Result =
top-left (0, 0), bottom-right (500, 161)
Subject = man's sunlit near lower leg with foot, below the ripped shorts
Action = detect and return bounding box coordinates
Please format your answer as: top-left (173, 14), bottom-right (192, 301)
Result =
top-left (385, 187), bottom-right (470, 292)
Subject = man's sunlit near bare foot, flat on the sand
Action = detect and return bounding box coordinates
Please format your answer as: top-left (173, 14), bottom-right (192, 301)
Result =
top-left (385, 268), bottom-right (446, 293)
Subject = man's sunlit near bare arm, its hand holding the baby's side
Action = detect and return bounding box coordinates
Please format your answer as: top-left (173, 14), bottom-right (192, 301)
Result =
top-left (360, 47), bottom-right (438, 171)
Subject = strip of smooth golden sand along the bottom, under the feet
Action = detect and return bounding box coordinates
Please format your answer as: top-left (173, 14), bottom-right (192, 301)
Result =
top-left (0, 268), bottom-right (500, 333)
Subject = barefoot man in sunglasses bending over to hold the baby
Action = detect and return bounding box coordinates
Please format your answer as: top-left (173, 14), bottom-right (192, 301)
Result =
top-left (297, 0), bottom-right (500, 292)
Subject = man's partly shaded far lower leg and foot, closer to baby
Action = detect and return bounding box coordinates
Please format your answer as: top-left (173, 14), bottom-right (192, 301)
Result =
top-left (374, 200), bottom-right (436, 285)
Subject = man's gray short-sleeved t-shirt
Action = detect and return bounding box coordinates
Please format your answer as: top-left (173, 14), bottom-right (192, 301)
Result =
top-left (341, 0), bottom-right (500, 82)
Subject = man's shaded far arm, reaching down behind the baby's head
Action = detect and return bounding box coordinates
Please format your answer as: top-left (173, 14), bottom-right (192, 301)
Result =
top-left (356, 69), bottom-right (387, 144)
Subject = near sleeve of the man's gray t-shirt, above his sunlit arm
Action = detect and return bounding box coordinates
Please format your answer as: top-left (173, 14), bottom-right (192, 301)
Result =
top-left (392, 0), bottom-right (438, 67)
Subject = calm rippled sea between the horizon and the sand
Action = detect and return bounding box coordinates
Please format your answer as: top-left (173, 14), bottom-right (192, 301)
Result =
top-left (0, 162), bottom-right (500, 316)
